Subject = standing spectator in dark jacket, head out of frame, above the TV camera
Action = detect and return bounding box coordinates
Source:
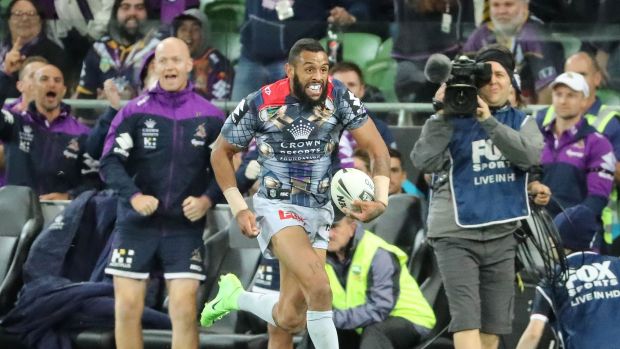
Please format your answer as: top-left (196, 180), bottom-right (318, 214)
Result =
top-left (392, 0), bottom-right (474, 119)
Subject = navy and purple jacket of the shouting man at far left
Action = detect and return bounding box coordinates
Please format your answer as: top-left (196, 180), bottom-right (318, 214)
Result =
top-left (0, 103), bottom-right (97, 196)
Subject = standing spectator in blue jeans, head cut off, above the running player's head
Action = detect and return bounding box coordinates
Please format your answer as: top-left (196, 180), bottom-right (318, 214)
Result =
top-left (233, 0), bottom-right (369, 101)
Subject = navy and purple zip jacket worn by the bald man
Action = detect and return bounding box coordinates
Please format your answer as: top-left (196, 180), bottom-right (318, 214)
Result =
top-left (101, 85), bottom-right (224, 229)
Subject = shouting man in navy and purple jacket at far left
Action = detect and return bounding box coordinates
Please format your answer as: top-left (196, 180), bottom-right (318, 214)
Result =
top-left (0, 65), bottom-right (98, 200)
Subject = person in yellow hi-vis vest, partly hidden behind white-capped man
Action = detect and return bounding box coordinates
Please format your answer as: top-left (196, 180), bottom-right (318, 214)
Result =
top-left (536, 52), bottom-right (620, 244)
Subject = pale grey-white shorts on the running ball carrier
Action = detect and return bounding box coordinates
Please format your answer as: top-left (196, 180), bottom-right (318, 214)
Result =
top-left (253, 195), bottom-right (334, 258)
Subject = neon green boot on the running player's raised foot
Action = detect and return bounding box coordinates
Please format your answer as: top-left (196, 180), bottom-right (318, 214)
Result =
top-left (200, 274), bottom-right (243, 327)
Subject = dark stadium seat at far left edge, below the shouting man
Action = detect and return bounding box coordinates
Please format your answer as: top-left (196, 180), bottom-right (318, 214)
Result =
top-left (0, 186), bottom-right (43, 315)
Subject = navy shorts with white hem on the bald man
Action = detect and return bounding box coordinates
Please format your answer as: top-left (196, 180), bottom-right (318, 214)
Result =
top-left (105, 230), bottom-right (205, 280)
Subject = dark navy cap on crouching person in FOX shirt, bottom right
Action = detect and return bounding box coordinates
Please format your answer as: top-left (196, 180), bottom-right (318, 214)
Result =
top-left (553, 205), bottom-right (602, 251)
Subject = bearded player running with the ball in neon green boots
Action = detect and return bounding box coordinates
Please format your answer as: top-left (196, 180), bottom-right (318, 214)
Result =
top-left (201, 39), bottom-right (390, 349)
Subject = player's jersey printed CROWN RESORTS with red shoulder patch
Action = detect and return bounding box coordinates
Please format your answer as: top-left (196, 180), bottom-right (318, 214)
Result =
top-left (222, 79), bottom-right (368, 207)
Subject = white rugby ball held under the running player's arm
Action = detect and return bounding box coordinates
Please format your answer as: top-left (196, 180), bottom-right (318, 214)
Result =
top-left (330, 168), bottom-right (375, 212)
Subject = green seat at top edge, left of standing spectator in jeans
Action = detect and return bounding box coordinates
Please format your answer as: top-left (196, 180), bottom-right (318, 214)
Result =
top-left (204, 0), bottom-right (245, 32)
